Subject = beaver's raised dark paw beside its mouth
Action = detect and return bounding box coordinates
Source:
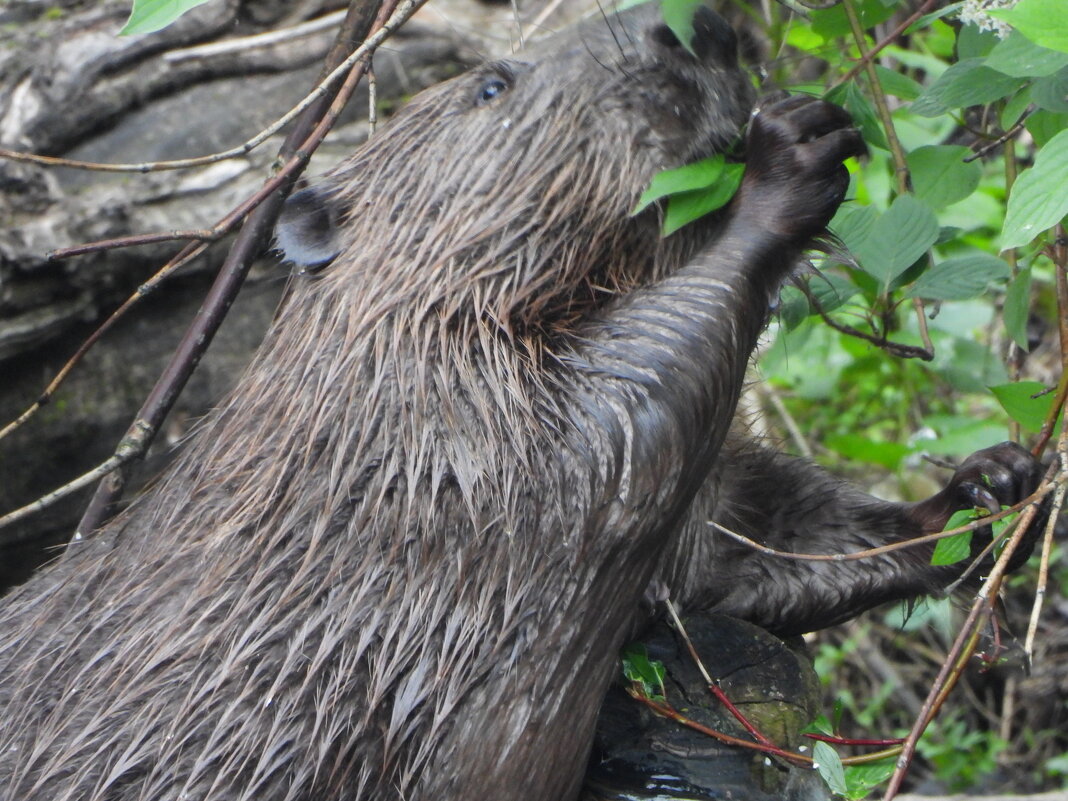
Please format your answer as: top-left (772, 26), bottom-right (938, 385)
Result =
top-left (738, 95), bottom-right (866, 245)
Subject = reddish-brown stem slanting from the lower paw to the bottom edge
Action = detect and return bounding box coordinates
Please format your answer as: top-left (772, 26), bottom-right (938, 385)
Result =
top-left (883, 499), bottom-right (1038, 801)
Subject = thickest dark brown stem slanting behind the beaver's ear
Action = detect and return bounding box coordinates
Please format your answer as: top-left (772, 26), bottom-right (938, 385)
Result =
top-left (75, 0), bottom-right (407, 536)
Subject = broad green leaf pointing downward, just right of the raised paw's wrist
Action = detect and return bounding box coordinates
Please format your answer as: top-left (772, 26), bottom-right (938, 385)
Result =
top-left (855, 194), bottom-right (939, 290)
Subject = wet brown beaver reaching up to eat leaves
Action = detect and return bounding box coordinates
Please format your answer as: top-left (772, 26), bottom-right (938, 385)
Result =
top-left (0, 5), bottom-right (1036, 801)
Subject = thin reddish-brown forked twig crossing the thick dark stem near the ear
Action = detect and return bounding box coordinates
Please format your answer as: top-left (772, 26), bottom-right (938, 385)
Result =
top-left (0, 0), bottom-right (426, 448)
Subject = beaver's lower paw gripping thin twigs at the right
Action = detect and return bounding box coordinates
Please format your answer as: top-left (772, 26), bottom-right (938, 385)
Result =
top-left (912, 442), bottom-right (1049, 569)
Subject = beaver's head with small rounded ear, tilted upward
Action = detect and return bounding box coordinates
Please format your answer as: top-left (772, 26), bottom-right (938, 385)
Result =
top-left (279, 3), bottom-right (753, 334)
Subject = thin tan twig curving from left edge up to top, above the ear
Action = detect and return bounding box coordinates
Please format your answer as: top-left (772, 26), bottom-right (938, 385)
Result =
top-left (0, 0), bottom-right (414, 172)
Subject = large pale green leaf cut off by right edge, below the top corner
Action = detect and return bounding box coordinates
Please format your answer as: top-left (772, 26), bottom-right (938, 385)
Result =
top-left (1001, 130), bottom-right (1068, 250)
